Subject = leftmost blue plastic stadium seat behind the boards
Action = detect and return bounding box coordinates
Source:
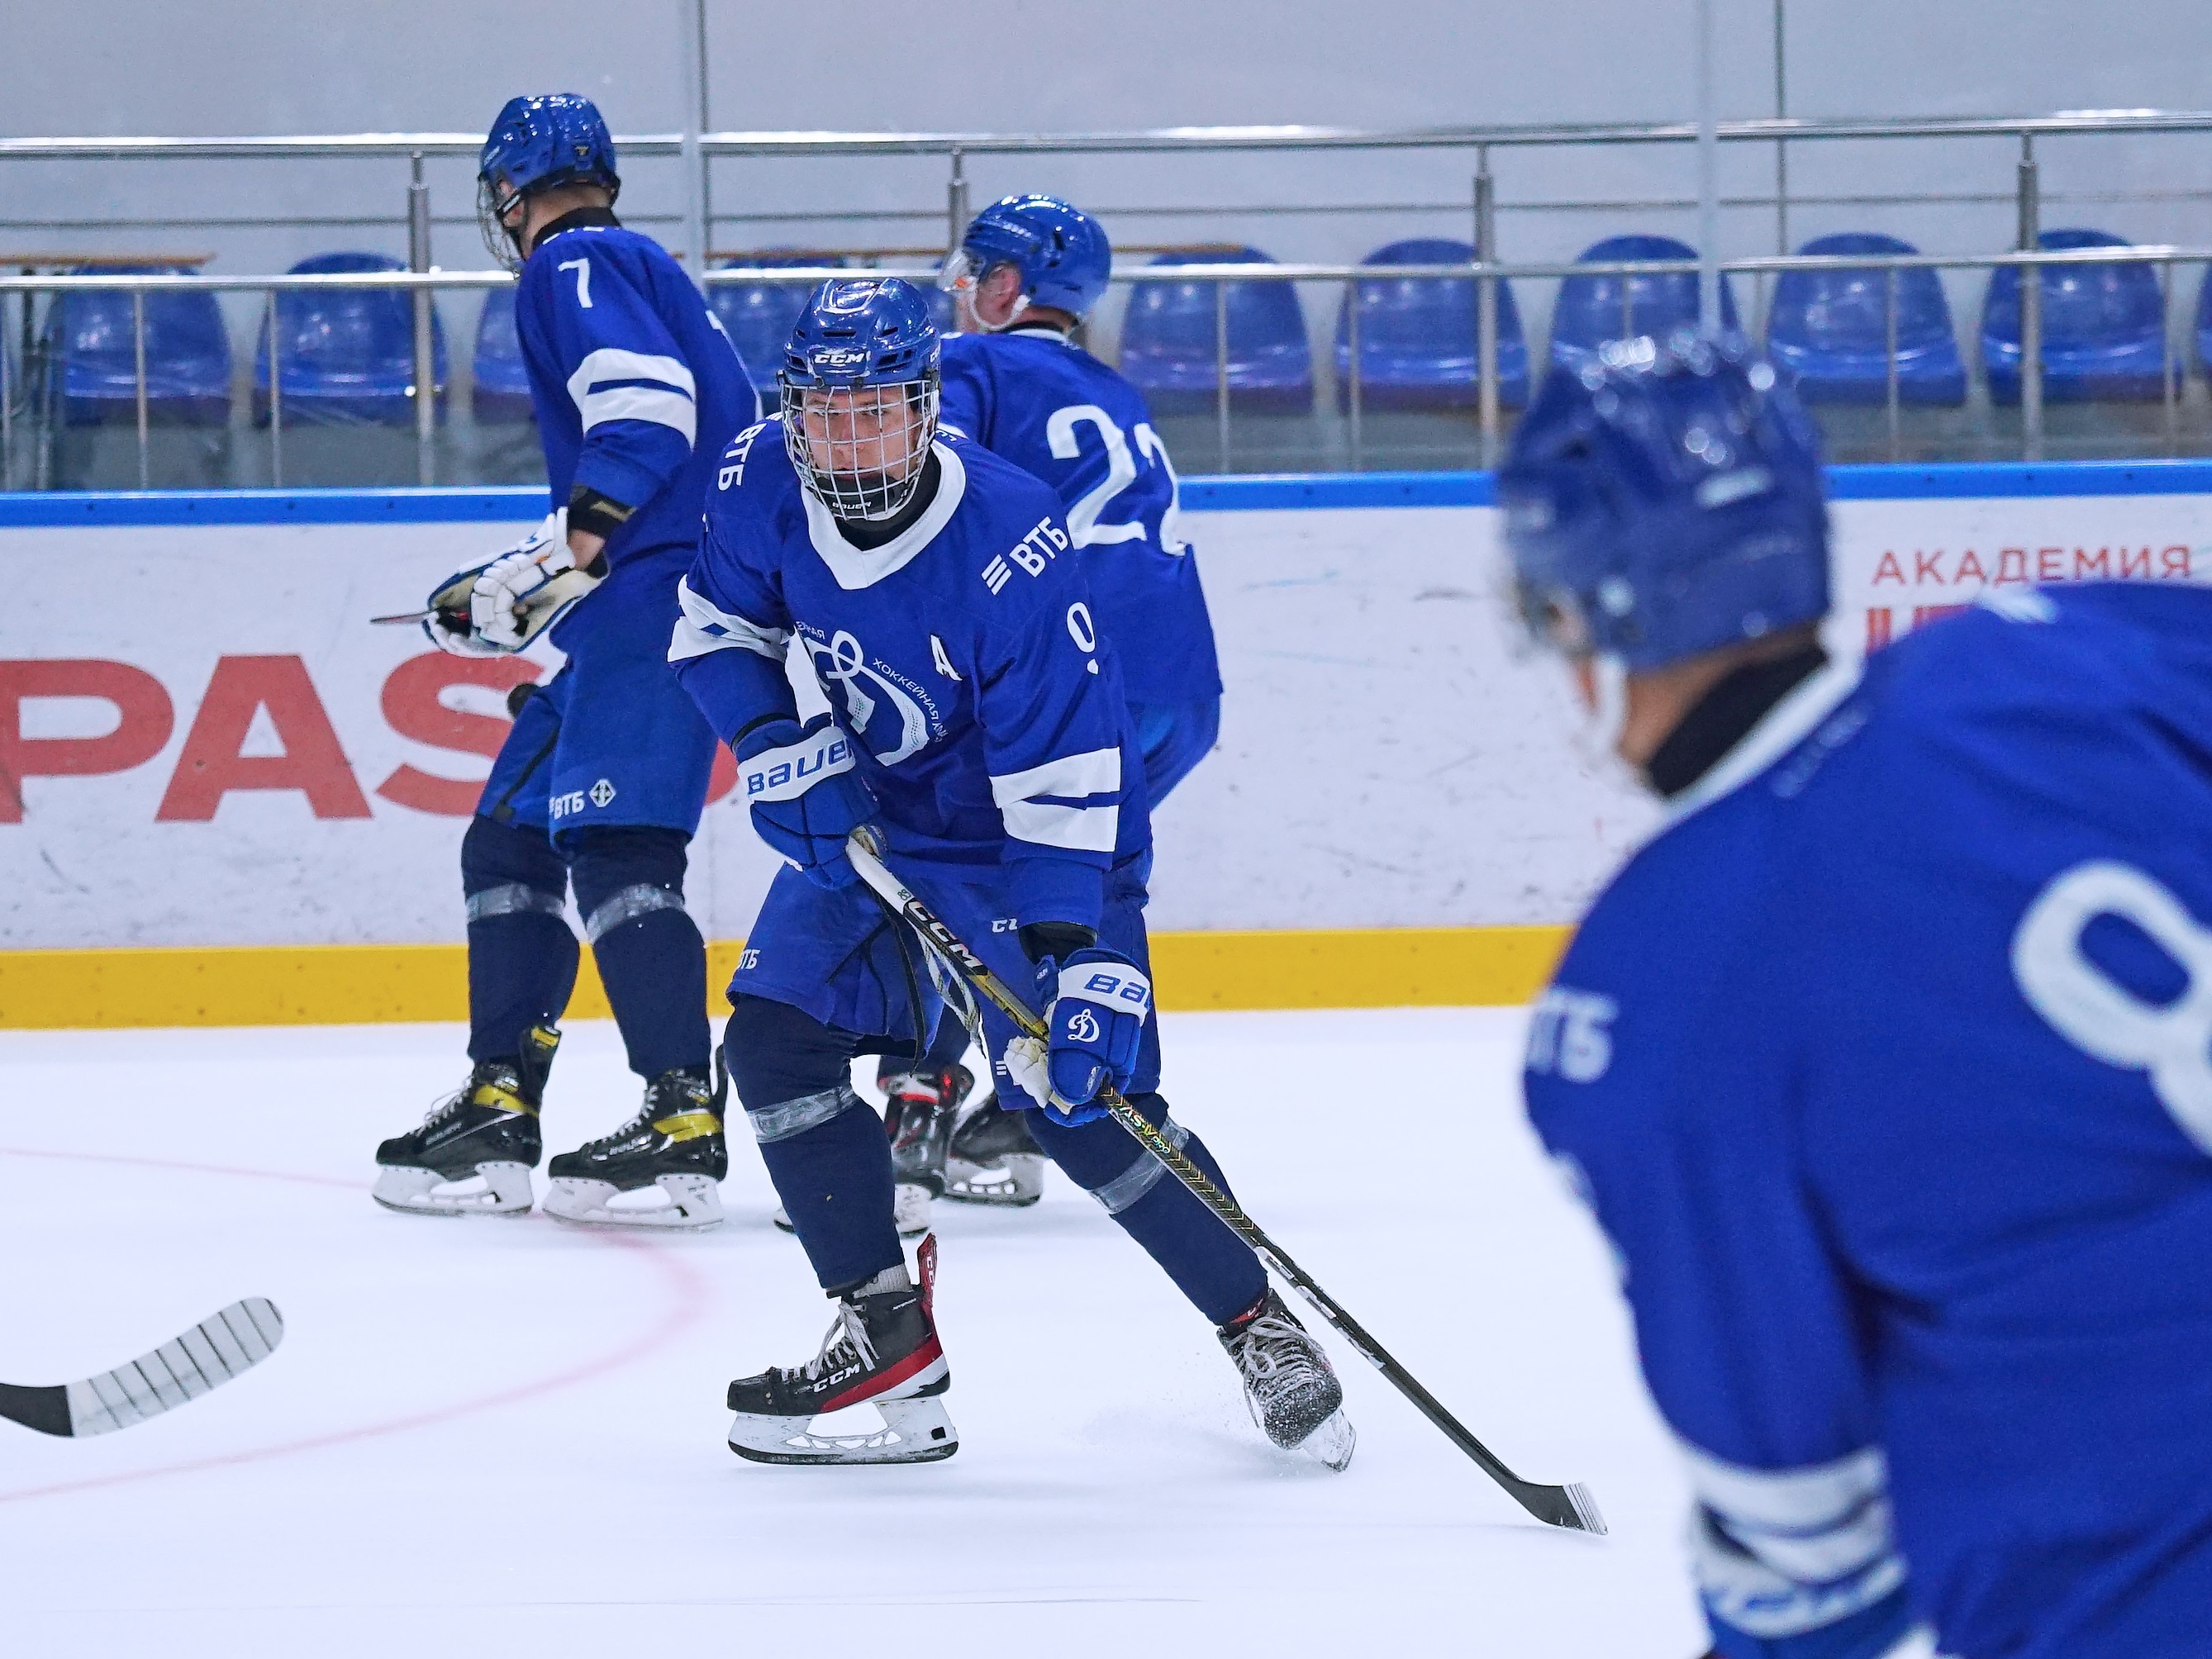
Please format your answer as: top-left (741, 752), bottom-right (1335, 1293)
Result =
top-left (45, 265), bottom-right (230, 427)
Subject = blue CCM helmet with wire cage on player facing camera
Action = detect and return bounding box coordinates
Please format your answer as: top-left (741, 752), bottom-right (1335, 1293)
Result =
top-left (777, 277), bottom-right (938, 520)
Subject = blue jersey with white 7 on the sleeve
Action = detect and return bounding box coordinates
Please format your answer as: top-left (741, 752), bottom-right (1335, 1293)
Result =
top-left (516, 212), bottom-right (759, 592)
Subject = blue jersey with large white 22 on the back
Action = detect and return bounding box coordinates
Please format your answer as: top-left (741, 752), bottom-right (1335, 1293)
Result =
top-left (942, 327), bottom-right (1221, 703)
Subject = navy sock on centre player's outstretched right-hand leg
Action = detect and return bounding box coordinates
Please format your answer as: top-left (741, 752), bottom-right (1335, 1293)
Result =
top-left (1029, 1095), bottom-right (1268, 1325)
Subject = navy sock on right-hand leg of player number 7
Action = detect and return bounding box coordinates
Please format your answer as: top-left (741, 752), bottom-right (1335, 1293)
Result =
top-left (566, 827), bottom-right (710, 1081)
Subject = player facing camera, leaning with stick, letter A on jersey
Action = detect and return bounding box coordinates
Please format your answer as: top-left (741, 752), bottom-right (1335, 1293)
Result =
top-left (670, 277), bottom-right (1349, 1462)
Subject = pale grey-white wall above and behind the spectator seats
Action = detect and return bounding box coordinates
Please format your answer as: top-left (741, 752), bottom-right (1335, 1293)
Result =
top-left (0, 0), bottom-right (2212, 285)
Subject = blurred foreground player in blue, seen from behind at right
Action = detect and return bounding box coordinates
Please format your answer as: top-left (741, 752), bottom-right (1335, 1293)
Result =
top-left (1500, 336), bottom-right (2212, 1659)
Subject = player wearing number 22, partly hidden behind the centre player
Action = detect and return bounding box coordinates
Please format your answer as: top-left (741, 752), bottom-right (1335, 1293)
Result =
top-left (844, 195), bottom-right (1221, 1230)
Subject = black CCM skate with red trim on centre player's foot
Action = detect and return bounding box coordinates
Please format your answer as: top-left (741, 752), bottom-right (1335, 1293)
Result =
top-left (728, 1237), bottom-right (960, 1462)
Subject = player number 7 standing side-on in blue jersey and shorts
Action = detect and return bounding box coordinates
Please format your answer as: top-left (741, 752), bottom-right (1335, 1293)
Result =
top-left (376, 95), bottom-right (759, 1228)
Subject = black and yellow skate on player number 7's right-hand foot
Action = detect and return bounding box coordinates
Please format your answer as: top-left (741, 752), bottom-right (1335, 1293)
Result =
top-left (546, 1066), bottom-right (730, 1228)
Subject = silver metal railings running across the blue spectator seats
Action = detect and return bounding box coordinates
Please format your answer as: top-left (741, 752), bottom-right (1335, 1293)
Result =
top-left (12, 111), bottom-right (2212, 487)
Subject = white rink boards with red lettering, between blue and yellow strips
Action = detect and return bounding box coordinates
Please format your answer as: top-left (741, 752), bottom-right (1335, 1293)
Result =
top-left (0, 496), bottom-right (2212, 949)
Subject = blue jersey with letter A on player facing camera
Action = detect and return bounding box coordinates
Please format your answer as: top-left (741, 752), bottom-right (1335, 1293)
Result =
top-left (668, 418), bottom-right (1150, 927)
